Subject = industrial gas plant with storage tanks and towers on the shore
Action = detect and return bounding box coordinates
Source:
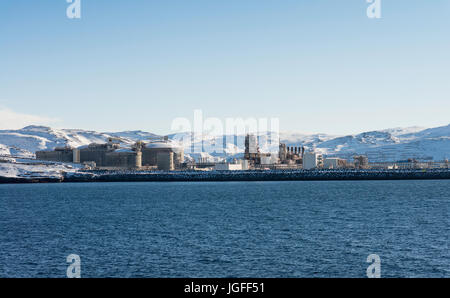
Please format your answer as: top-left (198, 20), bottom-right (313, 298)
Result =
top-left (36, 135), bottom-right (449, 171)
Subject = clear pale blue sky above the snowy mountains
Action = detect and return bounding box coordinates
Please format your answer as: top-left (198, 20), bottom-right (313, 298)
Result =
top-left (0, 0), bottom-right (450, 134)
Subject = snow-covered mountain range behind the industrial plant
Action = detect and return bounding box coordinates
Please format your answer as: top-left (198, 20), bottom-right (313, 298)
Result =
top-left (0, 125), bottom-right (450, 161)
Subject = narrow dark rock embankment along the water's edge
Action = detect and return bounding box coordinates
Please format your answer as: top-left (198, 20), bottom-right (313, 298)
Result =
top-left (0, 169), bottom-right (450, 184)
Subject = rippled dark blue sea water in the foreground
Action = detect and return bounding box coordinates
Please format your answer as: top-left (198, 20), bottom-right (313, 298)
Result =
top-left (0, 180), bottom-right (450, 277)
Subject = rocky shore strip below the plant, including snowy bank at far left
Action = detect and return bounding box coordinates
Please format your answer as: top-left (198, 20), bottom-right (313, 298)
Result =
top-left (0, 164), bottom-right (450, 183)
